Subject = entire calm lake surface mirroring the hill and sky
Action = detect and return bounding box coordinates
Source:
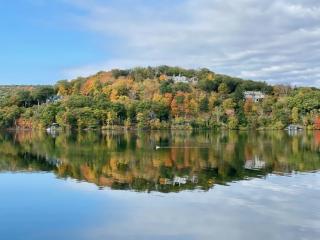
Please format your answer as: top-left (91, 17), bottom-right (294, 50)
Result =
top-left (0, 131), bottom-right (320, 240)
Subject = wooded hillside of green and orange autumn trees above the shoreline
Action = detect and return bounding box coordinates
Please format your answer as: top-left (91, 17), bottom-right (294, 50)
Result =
top-left (0, 66), bottom-right (320, 129)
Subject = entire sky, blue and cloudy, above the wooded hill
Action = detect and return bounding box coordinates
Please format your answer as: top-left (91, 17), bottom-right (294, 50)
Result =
top-left (0, 0), bottom-right (320, 87)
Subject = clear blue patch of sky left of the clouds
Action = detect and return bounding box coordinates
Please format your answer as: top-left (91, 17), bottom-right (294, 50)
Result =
top-left (0, 0), bottom-right (108, 84)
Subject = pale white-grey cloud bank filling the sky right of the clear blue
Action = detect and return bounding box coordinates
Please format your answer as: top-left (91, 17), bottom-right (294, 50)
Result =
top-left (64, 0), bottom-right (320, 86)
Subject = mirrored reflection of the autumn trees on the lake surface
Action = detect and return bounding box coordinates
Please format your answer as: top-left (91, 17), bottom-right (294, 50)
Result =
top-left (0, 131), bottom-right (320, 192)
